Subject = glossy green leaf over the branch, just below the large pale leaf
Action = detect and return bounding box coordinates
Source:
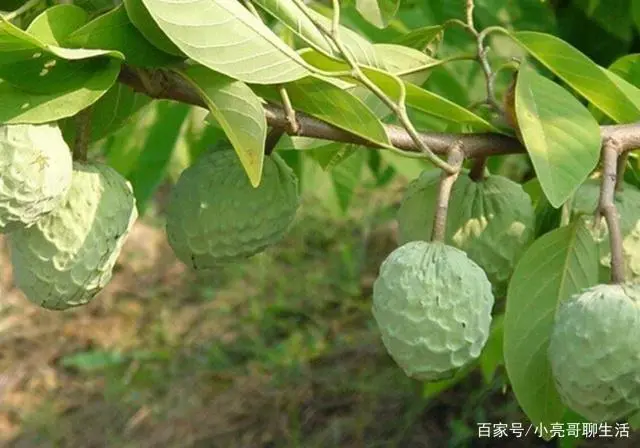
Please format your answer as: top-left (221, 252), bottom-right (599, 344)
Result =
top-left (254, 77), bottom-right (391, 147)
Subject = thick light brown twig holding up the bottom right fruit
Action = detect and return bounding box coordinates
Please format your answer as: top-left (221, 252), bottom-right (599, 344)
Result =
top-left (595, 138), bottom-right (624, 283)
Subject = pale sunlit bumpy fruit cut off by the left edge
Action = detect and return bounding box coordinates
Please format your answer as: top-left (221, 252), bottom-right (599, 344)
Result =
top-left (0, 124), bottom-right (72, 233)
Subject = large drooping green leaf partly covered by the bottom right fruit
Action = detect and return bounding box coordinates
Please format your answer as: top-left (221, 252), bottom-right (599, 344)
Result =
top-left (504, 220), bottom-right (598, 434)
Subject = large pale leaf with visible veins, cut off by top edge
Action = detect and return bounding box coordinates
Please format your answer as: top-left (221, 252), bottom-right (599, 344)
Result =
top-left (142, 0), bottom-right (308, 84)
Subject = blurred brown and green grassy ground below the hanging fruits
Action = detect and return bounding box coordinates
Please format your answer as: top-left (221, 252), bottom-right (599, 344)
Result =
top-left (0, 183), bottom-right (637, 448)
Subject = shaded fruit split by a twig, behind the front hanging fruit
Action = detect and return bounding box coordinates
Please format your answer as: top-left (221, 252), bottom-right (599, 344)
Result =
top-left (398, 170), bottom-right (535, 285)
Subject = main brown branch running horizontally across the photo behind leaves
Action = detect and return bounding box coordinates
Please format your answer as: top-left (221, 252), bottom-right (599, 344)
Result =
top-left (118, 65), bottom-right (640, 158)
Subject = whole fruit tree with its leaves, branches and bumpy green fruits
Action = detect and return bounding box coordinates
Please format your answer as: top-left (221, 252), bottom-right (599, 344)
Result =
top-left (0, 0), bottom-right (640, 437)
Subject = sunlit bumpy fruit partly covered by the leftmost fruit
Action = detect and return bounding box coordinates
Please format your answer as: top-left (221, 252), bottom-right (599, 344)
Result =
top-left (9, 163), bottom-right (138, 310)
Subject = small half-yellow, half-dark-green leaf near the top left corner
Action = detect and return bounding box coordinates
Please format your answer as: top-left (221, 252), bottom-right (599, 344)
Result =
top-left (26, 5), bottom-right (89, 46)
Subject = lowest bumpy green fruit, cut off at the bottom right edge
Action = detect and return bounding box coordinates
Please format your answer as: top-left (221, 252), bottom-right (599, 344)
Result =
top-left (548, 284), bottom-right (640, 422)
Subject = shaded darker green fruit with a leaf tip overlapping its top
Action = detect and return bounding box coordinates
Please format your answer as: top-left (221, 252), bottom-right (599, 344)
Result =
top-left (167, 148), bottom-right (299, 270)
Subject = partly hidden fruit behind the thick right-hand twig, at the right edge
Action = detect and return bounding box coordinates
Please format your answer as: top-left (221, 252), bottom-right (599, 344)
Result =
top-left (572, 179), bottom-right (640, 280)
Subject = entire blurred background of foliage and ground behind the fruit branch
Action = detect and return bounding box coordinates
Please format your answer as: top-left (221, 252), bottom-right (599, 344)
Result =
top-left (0, 0), bottom-right (640, 448)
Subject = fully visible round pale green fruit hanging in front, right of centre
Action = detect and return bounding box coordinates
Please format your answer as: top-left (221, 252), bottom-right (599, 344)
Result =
top-left (373, 241), bottom-right (494, 381)
